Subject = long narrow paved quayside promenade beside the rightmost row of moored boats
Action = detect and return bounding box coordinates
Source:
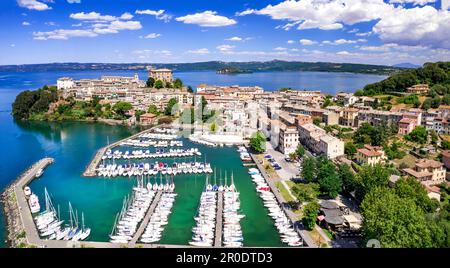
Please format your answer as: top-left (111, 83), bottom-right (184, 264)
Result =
top-left (250, 153), bottom-right (318, 248)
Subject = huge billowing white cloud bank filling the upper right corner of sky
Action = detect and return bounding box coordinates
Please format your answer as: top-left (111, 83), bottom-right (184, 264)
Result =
top-left (241, 0), bottom-right (450, 49)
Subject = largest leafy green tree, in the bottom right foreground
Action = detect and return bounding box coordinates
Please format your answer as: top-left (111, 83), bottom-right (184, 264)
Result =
top-left (361, 187), bottom-right (432, 248)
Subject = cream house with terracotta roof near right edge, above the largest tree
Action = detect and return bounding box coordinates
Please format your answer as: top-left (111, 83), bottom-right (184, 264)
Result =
top-left (402, 159), bottom-right (446, 185)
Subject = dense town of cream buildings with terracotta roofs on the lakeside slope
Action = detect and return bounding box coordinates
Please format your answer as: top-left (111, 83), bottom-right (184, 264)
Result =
top-left (51, 68), bottom-right (450, 245)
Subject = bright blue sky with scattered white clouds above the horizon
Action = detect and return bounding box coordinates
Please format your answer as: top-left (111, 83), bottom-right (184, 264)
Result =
top-left (0, 0), bottom-right (450, 65)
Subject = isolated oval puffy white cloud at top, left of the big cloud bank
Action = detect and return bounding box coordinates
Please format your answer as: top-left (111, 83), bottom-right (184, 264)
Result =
top-left (176, 10), bottom-right (237, 27)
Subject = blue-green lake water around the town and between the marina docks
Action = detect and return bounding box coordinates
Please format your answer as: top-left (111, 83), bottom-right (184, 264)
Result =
top-left (0, 71), bottom-right (384, 247)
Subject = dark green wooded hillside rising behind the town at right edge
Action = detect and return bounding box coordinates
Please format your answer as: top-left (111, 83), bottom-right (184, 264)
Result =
top-left (357, 62), bottom-right (450, 95)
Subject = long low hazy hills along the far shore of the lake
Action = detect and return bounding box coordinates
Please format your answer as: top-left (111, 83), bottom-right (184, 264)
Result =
top-left (0, 60), bottom-right (399, 74)
